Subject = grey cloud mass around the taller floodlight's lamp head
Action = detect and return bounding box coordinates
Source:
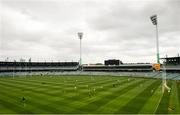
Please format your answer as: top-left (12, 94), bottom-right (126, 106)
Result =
top-left (89, 1), bottom-right (180, 39)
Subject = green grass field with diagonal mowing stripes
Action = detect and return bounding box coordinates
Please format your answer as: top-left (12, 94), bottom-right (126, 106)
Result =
top-left (0, 76), bottom-right (180, 114)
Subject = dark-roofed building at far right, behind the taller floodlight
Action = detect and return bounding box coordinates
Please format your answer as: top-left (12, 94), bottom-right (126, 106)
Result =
top-left (161, 56), bottom-right (180, 65)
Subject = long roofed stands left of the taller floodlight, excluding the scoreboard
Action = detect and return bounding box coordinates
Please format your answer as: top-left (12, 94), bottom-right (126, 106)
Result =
top-left (0, 62), bottom-right (153, 72)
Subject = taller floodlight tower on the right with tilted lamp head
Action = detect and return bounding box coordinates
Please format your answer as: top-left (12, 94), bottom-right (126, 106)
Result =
top-left (150, 15), bottom-right (160, 64)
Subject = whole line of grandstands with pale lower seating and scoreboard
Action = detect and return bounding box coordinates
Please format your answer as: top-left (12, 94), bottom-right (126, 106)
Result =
top-left (0, 57), bottom-right (180, 80)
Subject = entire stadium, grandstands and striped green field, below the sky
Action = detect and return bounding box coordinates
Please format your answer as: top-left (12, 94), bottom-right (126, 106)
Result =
top-left (0, 57), bottom-right (180, 114)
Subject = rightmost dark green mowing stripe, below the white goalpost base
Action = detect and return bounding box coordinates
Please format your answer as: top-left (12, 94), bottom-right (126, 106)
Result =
top-left (156, 81), bottom-right (172, 114)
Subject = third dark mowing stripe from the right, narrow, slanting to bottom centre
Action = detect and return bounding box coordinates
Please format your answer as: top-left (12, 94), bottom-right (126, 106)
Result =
top-left (71, 80), bottom-right (146, 113)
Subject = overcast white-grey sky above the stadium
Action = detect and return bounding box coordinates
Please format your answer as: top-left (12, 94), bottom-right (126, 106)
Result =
top-left (0, 0), bottom-right (180, 63)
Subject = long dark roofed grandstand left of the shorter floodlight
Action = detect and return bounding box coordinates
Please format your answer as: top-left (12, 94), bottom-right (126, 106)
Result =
top-left (0, 61), bottom-right (79, 72)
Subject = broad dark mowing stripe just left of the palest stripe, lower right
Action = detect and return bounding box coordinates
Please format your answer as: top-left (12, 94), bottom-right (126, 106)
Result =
top-left (115, 81), bottom-right (161, 114)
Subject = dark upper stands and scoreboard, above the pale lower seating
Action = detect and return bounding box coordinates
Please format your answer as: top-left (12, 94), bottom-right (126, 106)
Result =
top-left (0, 57), bottom-right (180, 73)
